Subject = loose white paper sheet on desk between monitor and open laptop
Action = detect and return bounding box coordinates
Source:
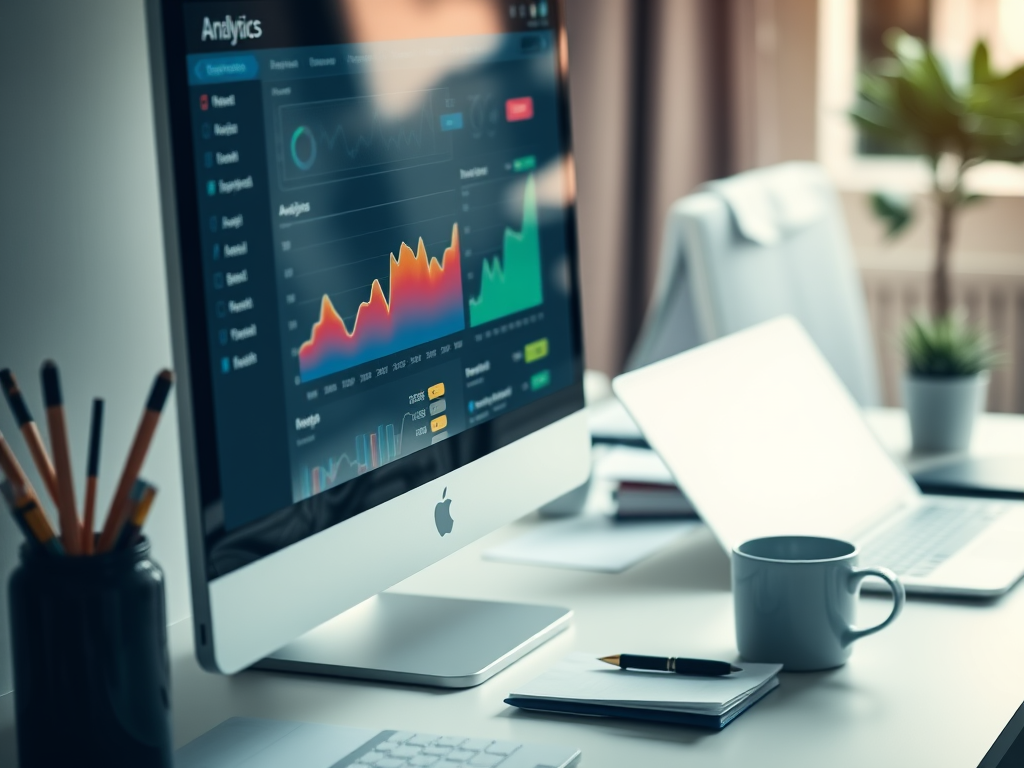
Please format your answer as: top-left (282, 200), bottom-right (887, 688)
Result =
top-left (483, 514), bottom-right (700, 573)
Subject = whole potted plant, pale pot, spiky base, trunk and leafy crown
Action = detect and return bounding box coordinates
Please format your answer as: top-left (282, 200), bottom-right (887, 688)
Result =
top-left (851, 30), bottom-right (1024, 451)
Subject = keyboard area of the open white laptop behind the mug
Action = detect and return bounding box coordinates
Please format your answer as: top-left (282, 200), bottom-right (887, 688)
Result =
top-left (860, 499), bottom-right (1007, 579)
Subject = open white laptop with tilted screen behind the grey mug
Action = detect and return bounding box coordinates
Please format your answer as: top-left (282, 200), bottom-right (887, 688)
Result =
top-left (612, 316), bottom-right (1024, 597)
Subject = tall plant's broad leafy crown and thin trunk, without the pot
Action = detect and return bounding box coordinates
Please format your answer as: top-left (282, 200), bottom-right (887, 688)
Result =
top-left (850, 30), bottom-right (1024, 318)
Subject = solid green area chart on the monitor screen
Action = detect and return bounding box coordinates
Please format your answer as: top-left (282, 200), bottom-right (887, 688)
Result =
top-left (469, 174), bottom-right (544, 327)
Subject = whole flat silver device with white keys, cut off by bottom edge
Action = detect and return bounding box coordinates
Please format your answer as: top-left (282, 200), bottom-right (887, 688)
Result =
top-left (174, 718), bottom-right (580, 768)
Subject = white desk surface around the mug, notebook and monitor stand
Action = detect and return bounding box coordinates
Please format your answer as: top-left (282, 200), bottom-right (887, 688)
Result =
top-left (0, 412), bottom-right (1024, 768)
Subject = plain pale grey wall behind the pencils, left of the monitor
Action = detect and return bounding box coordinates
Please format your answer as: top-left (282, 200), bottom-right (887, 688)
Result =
top-left (0, 0), bottom-right (189, 695)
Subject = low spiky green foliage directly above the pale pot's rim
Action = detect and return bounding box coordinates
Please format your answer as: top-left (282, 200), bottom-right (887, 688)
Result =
top-left (902, 313), bottom-right (997, 376)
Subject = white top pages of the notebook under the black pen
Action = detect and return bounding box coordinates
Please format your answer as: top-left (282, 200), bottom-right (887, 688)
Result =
top-left (511, 653), bottom-right (782, 711)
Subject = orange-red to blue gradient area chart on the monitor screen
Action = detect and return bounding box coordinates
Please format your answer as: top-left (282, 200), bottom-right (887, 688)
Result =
top-left (299, 224), bottom-right (466, 382)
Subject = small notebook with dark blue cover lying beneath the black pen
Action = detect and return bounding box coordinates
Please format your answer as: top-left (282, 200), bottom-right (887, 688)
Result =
top-left (505, 653), bottom-right (782, 730)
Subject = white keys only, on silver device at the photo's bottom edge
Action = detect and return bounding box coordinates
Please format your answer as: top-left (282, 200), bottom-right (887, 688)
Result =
top-left (332, 731), bottom-right (522, 768)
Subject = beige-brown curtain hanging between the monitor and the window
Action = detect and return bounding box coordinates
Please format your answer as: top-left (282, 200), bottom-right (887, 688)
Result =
top-left (568, 0), bottom-right (817, 373)
